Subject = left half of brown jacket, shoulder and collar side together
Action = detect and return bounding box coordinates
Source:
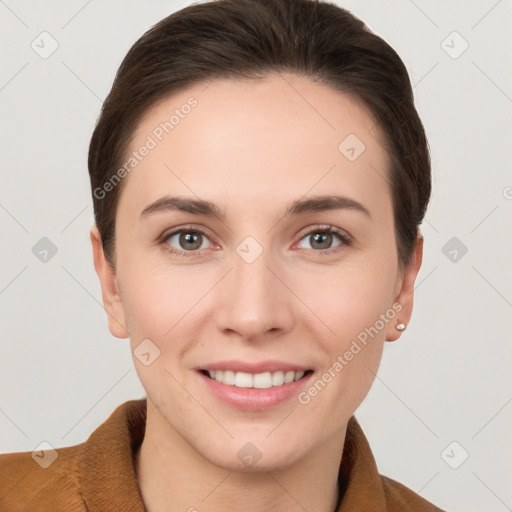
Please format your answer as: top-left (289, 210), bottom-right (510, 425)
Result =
top-left (0, 399), bottom-right (146, 512)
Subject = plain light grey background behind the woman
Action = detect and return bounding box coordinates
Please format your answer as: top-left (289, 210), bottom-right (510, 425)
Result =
top-left (0, 0), bottom-right (512, 512)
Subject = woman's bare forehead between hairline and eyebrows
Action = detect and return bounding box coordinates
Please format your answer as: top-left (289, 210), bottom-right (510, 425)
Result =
top-left (121, 74), bottom-right (388, 211)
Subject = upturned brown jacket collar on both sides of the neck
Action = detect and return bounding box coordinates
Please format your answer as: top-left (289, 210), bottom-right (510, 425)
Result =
top-left (80, 398), bottom-right (386, 512)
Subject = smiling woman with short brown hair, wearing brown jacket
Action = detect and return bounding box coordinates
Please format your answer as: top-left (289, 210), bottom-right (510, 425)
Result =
top-left (0, 0), bottom-right (446, 512)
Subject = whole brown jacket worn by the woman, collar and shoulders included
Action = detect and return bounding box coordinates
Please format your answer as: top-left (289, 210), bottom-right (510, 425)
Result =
top-left (0, 399), bottom-right (442, 512)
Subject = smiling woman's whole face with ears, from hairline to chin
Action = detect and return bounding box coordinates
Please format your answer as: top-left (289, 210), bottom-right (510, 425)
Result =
top-left (91, 75), bottom-right (421, 470)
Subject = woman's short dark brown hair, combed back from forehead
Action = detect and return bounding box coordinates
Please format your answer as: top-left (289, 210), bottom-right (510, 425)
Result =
top-left (88, 0), bottom-right (431, 267)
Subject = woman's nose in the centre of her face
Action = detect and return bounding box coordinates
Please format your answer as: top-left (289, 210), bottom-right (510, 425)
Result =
top-left (215, 244), bottom-right (297, 342)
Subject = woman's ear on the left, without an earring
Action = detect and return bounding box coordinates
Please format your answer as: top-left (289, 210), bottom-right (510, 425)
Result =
top-left (90, 224), bottom-right (130, 338)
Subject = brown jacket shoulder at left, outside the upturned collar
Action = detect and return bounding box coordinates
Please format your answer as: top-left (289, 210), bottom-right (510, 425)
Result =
top-left (0, 443), bottom-right (86, 512)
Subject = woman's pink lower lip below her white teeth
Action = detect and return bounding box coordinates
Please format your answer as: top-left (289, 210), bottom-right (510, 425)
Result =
top-left (198, 372), bottom-right (313, 411)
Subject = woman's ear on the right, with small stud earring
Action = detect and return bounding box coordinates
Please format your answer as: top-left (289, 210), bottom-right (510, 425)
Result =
top-left (386, 235), bottom-right (423, 341)
